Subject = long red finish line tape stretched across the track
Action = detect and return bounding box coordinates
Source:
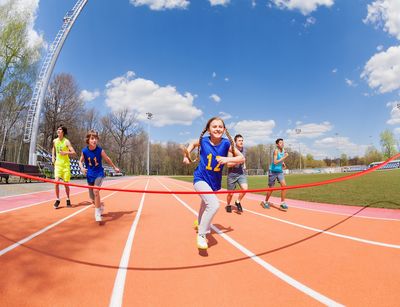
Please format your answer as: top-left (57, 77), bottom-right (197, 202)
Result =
top-left (0, 153), bottom-right (400, 194)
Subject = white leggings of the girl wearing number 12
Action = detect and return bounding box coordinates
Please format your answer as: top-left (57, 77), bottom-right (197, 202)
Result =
top-left (194, 181), bottom-right (219, 235)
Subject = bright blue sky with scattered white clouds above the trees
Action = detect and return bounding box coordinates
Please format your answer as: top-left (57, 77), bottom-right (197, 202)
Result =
top-left (4, 0), bottom-right (400, 159)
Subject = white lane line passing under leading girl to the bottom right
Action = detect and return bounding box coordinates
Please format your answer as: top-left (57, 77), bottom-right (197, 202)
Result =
top-left (156, 179), bottom-right (344, 306)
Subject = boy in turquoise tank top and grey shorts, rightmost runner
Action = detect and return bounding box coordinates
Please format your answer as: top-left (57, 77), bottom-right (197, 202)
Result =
top-left (260, 139), bottom-right (288, 210)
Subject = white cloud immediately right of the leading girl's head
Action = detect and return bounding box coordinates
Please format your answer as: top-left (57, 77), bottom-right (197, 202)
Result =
top-left (229, 120), bottom-right (275, 146)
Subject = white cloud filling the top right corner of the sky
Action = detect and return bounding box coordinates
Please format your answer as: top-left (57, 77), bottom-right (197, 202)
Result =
top-left (363, 0), bottom-right (400, 39)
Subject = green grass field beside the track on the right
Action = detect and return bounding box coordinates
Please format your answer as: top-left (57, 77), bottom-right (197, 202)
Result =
top-left (172, 169), bottom-right (400, 209)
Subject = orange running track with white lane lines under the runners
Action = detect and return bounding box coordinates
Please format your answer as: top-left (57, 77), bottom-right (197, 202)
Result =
top-left (0, 177), bottom-right (400, 306)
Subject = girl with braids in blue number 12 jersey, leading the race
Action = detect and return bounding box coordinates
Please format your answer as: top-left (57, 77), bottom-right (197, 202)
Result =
top-left (183, 117), bottom-right (245, 249)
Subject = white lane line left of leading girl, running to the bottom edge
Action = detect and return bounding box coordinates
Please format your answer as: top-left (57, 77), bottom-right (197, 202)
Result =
top-left (109, 179), bottom-right (150, 307)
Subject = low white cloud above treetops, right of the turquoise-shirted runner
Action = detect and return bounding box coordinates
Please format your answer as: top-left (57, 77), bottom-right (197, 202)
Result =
top-left (313, 136), bottom-right (368, 157)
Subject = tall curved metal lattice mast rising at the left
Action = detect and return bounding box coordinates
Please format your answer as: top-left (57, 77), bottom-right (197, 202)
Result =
top-left (24, 0), bottom-right (88, 165)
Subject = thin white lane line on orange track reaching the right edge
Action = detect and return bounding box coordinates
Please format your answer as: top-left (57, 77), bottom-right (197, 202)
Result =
top-left (169, 180), bottom-right (400, 249)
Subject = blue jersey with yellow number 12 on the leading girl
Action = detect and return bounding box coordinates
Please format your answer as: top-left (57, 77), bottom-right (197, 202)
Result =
top-left (193, 136), bottom-right (231, 191)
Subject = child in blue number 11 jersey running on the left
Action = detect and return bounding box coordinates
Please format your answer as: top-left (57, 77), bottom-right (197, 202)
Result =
top-left (79, 130), bottom-right (120, 222)
